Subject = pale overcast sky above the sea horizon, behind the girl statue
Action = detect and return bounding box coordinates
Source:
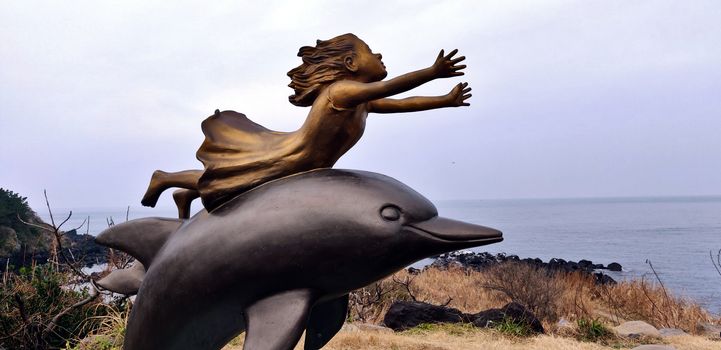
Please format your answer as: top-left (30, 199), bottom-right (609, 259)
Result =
top-left (0, 0), bottom-right (721, 210)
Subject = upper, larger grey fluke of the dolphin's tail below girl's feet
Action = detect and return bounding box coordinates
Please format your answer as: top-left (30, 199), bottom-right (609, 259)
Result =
top-left (95, 218), bottom-right (183, 268)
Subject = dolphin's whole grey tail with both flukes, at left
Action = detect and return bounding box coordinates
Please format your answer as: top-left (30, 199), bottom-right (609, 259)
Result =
top-left (95, 218), bottom-right (183, 295)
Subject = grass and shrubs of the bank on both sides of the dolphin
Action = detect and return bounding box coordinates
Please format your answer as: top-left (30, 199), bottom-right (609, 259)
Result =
top-left (0, 262), bottom-right (721, 350)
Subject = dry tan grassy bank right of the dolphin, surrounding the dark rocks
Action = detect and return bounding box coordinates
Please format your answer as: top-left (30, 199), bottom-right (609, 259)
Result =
top-left (225, 263), bottom-right (721, 350)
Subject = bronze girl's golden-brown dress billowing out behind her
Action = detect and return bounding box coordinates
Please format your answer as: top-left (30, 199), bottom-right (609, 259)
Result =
top-left (196, 88), bottom-right (368, 211)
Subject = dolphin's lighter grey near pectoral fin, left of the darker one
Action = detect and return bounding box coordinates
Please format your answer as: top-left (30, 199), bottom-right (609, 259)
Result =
top-left (243, 290), bottom-right (314, 350)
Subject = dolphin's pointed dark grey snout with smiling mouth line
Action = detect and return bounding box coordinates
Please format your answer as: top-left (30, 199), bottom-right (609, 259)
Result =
top-left (407, 216), bottom-right (503, 244)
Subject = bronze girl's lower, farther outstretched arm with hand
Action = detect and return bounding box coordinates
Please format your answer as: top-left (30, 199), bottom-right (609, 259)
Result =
top-left (368, 83), bottom-right (473, 113)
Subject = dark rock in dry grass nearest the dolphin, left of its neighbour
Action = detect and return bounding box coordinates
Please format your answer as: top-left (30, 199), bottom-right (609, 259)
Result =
top-left (383, 301), bottom-right (470, 331)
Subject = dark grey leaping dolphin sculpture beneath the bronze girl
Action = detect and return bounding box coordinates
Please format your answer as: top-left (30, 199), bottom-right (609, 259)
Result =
top-left (96, 169), bottom-right (503, 350)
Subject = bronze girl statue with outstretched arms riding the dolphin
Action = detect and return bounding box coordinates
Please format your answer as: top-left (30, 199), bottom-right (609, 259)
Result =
top-left (141, 34), bottom-right (471, 218)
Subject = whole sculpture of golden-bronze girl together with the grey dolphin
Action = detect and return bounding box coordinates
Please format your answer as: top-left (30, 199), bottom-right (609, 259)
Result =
top-left (97, 34), bottom-right (490, 350)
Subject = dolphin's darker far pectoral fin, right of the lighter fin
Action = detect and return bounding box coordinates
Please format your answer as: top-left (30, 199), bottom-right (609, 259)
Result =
top-left (305, 294), bottom-right (348, 350)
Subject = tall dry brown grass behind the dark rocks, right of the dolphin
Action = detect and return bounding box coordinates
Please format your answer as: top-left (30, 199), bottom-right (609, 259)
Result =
top-left (351, 263), bottom-right (719, 333)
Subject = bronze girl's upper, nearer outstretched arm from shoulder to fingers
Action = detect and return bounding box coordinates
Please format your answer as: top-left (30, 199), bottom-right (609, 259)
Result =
top-left (330, 50), bottom-right (466, 108)
